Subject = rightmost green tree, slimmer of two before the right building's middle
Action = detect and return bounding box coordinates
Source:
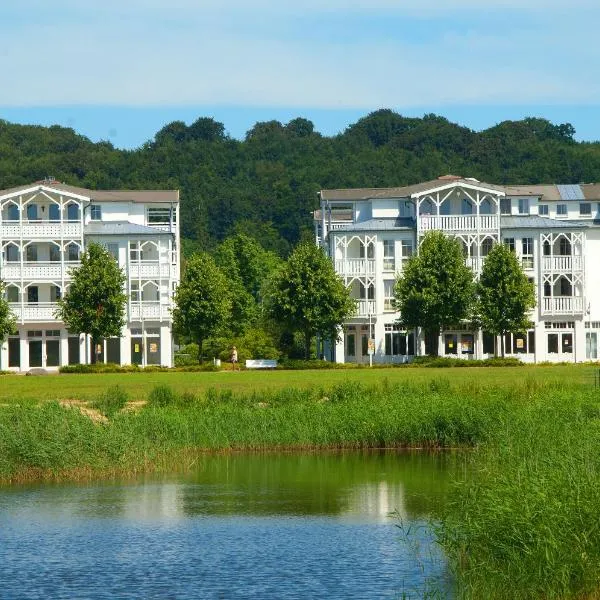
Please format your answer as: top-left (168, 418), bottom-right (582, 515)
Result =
top-left (477, 244), bottom-right (535, 357)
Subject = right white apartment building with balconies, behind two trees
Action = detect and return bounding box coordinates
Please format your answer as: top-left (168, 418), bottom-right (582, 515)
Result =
top-left (315, 175), bottom-right (600, 363)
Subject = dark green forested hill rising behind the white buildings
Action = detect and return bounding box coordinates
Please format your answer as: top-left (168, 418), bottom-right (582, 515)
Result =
top-left (0, 110), bottom-right (600, 254)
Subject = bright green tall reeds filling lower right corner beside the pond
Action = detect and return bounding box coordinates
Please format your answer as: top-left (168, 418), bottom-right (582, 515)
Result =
top-left (438, 389), bottom-right (600, 600)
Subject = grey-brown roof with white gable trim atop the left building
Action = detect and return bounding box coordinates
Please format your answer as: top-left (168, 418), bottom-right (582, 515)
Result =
top-left (0, 180), bottom-right (179, 204)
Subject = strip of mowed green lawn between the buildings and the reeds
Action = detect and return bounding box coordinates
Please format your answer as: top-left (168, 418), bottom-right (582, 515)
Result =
top-left (0, 365), bottom-right (600, 403)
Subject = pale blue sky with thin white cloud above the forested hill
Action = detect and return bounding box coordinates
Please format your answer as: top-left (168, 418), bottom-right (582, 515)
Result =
top-left (0, 0), bottom-right (600, 148)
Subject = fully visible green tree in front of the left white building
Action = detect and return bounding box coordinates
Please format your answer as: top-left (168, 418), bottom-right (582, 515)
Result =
top-left (56, 243), bottom-right (127, 362)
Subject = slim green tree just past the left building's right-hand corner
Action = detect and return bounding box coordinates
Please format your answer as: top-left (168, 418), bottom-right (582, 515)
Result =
top-left (173, 253), bottom-right (231, 363)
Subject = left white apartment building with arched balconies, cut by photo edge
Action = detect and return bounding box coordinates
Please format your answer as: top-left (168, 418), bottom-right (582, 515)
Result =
top-left (0, 179), bottom-right (180, 371)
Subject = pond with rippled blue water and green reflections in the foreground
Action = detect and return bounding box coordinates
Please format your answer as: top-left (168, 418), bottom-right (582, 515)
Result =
top-left (0, 451), bottom-right (459, 599)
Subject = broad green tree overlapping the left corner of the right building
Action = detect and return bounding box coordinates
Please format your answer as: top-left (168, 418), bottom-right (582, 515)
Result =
top-left (265, 242), bottom-right (356, 359)
